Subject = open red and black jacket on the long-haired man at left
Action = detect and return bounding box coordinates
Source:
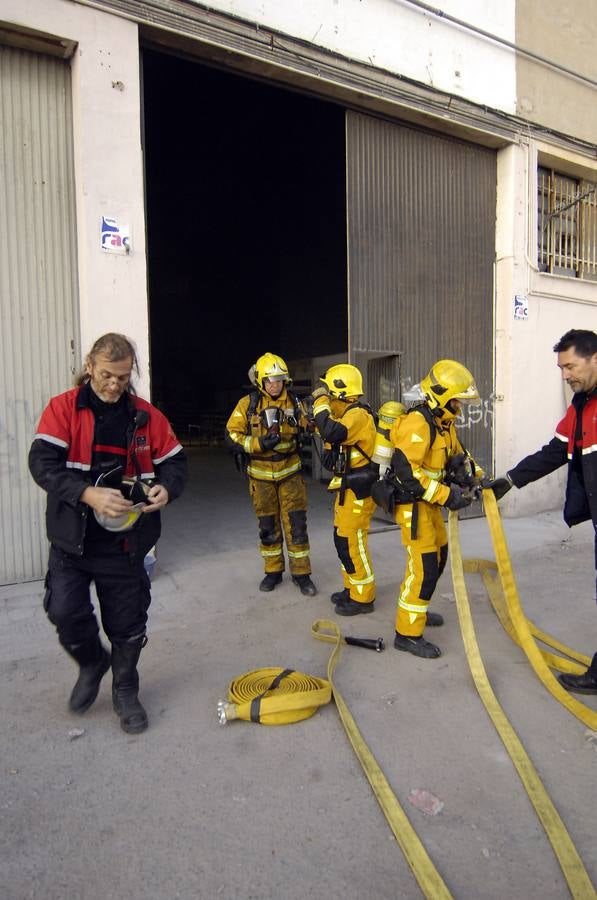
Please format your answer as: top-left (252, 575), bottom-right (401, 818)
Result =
top-left (29, 385), bottom-right (186, 559)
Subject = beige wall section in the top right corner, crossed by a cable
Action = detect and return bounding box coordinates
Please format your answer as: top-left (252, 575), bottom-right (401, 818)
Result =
top-left (516, 0), bottom-right (597, 143)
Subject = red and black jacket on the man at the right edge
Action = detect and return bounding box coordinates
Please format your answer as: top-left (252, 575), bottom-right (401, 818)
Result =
top-left (508, 389), bottom-right (597, 527)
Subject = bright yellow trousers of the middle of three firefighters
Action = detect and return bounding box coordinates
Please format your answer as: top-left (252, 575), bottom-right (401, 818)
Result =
top-left (334, 488), bottom-right (375, 603)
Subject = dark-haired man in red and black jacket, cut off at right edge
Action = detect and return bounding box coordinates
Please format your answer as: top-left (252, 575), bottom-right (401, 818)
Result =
top-left (487, 329), bottom-right (597, 694)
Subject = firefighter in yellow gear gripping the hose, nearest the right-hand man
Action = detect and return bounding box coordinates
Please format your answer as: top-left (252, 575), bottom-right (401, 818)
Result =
top-left (390, 359), bottom-right (483, 659)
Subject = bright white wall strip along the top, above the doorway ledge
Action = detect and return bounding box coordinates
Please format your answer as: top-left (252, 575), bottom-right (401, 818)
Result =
top-left (192, 0), bottom-right (516, 112)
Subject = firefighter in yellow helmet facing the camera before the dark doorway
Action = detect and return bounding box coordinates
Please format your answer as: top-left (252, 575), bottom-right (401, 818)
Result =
top-left (226, 353), bottom-right (317, 597)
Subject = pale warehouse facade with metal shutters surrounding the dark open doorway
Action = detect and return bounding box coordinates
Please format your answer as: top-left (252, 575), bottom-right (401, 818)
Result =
top-left (0, 0), bottom-right (597, 583)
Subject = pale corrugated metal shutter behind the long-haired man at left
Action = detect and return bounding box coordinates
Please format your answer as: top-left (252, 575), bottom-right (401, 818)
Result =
top-left (0, 46), bottom-right (80, 584)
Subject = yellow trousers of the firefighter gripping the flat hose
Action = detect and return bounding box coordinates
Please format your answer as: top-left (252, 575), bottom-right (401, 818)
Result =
top-left (396, 500), bottom-right (448, 637)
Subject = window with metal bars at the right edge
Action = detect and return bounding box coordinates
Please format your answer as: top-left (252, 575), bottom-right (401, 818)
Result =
top-left (537, 166), bottom-right (597, 281)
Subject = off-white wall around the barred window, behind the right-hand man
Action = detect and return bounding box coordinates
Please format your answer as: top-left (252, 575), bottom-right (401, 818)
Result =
top-left (494, 141), bottom-right (597, 515)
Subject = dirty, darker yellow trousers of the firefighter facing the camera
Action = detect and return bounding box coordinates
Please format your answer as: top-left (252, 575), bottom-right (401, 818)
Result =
top-left (249, 474), bottom-right (311, 575)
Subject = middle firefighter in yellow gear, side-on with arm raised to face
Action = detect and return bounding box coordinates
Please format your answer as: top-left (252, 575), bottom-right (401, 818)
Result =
top-left (313, 364), bottom-right (378, 616)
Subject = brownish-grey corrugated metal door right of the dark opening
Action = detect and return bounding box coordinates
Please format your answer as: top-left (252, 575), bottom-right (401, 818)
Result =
top-left (346, 112), bottom-right (496, 486)
